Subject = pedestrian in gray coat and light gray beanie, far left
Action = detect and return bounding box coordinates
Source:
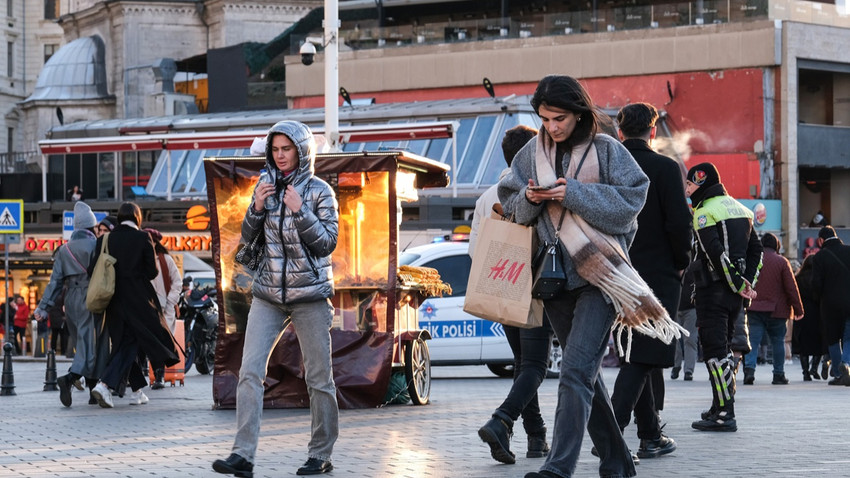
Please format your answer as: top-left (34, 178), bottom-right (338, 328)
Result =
top-left (35, 201), bottom-right (109, 407)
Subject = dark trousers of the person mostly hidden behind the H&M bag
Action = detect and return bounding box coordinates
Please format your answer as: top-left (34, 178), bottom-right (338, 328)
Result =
top-left (497, 317), bottom-right (552, 434)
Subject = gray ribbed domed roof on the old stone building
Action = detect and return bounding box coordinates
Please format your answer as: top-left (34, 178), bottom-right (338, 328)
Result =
top-left (25, 36), bottom-right (110, 101)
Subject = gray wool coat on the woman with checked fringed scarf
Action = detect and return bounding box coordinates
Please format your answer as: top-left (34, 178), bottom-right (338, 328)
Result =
top-left (499, 134), bottom-right (649, 289)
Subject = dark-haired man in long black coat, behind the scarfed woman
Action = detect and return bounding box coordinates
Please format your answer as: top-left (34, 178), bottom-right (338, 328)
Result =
top-left (611, 103), bottom-right (692, 458)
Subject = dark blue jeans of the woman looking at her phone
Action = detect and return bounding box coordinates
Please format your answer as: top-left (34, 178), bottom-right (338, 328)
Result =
top-left (541, 286), bottom-right (635, 478)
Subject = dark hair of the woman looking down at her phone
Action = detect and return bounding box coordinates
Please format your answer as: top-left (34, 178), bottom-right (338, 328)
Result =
top-left (531, 75), bottom-right (611, 146)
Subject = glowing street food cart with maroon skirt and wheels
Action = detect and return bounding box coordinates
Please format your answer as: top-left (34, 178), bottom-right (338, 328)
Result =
top-left (204, 151), bottom-right (449, 408)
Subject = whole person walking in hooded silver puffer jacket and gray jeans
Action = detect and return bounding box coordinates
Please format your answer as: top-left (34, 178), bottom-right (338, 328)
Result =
top-left (213, 121), bottom-right (339, 476)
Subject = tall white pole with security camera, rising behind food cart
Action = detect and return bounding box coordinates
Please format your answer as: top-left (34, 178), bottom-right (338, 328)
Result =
top-left (324, 0), bottom-right (339, 152)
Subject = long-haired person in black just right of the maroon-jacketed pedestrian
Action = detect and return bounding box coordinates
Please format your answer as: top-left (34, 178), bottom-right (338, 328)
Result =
top-left (792, 256), bottom-right (827, 382)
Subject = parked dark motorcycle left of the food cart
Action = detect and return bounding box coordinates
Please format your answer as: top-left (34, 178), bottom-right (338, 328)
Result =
top-left (180, 287), bottom-right (218, 375)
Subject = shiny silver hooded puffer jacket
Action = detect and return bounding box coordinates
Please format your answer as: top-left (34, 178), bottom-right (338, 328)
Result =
top-left (242, 121), bottom-right (339, 304)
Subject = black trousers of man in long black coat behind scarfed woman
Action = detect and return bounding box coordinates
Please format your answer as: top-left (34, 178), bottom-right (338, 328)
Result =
top-left (611, 363), bottom-right (661, 440)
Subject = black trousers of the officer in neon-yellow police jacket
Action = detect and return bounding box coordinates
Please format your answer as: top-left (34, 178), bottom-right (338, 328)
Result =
top-left (694, 281), bottom-right (743, 361)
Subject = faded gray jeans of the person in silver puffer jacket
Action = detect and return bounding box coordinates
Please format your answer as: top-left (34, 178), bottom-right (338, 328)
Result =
top-left (233, 297), bottom-right (339, 463)
